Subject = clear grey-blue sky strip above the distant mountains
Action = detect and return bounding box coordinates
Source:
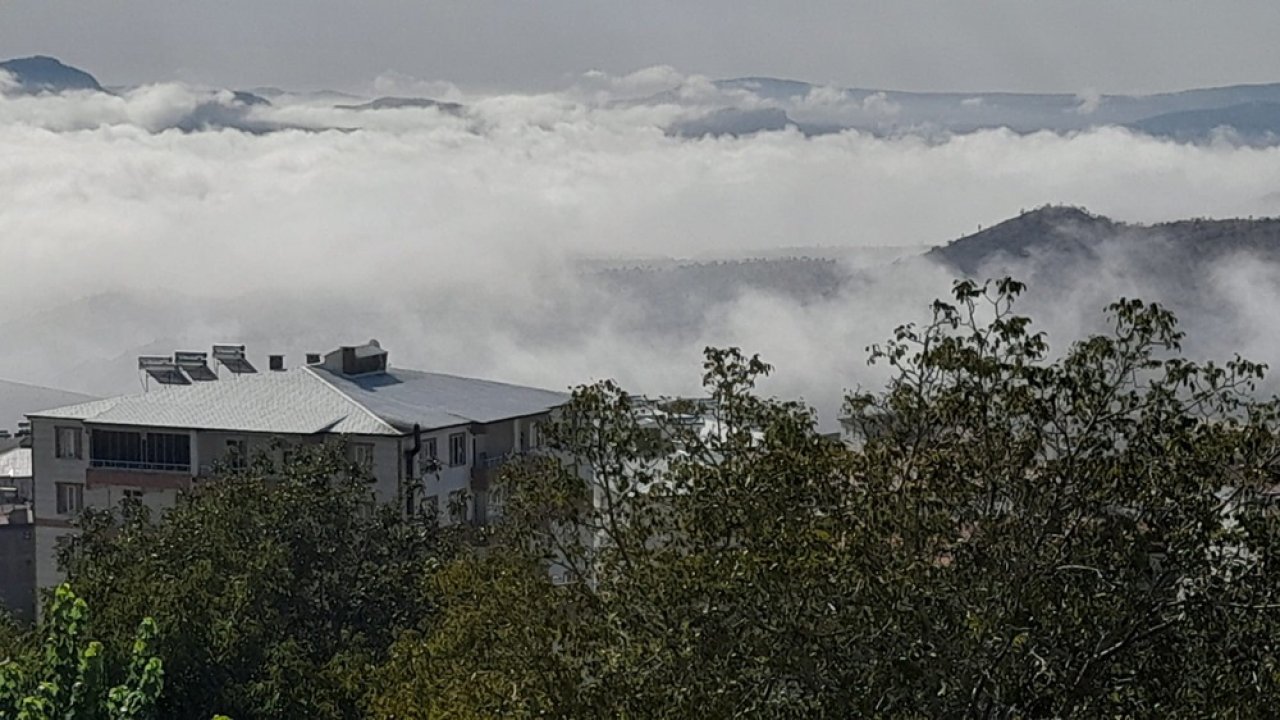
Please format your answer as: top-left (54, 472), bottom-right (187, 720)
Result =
top-left (0, 0), bottom-right (1280, 94)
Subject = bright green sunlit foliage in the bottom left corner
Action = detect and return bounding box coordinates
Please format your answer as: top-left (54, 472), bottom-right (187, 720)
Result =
top-left (0, 584), bottom-right (164, 720)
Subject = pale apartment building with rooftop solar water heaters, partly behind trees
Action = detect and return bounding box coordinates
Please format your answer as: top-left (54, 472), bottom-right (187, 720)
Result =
top-left (28, 341), bottom-right (568, 597)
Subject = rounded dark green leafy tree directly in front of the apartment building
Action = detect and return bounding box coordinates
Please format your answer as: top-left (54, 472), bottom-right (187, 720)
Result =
top-left (61, 443), bottom-right (444, 719)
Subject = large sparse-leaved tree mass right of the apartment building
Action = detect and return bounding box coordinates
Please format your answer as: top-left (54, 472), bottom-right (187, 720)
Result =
top-left (374, 281), bottom-right (1280, 719)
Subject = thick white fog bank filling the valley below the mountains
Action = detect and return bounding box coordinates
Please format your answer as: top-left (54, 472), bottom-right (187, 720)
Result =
top-left (0, 68), bottom-right (1280, 418)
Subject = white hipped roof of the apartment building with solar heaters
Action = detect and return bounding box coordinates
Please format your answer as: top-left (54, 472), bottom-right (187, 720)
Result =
top-left (31, 368), bottom-right (567, 436)
